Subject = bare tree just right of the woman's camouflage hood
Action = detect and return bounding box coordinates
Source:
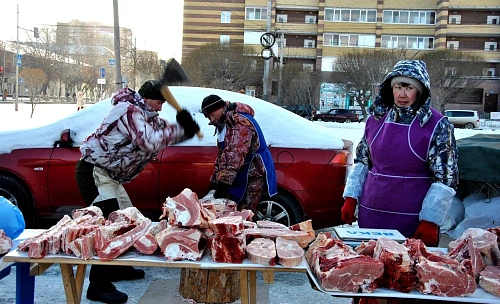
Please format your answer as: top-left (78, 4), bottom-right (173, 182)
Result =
top-left (419, 50), bottom-right (485, 112)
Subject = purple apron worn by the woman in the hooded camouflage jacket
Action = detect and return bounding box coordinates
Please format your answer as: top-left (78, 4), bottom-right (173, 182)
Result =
top-left (358, 109), bottom-right (443, 238)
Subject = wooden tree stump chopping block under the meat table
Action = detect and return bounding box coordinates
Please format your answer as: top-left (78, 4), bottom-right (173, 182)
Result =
top-left (179, 268), bottom-right (241, 303)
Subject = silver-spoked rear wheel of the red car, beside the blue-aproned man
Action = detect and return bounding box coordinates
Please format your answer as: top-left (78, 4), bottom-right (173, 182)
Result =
top-left (256, 193), bottom-right (304, 227)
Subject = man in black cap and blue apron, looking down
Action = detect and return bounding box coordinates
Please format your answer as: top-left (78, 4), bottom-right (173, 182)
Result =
top-left (201, 95), bottom-right (277, 213)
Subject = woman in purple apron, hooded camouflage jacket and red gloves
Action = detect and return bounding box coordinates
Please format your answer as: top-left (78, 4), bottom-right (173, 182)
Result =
top-left (341, 60), bottom-right (458, 246)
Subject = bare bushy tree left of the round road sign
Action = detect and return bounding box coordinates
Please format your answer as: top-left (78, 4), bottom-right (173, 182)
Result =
top-left (183, 43), bottom-right (262, 91)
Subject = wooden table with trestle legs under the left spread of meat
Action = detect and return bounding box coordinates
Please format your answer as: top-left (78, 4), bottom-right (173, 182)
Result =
top-left (3, 240), bottom-right (307, 304)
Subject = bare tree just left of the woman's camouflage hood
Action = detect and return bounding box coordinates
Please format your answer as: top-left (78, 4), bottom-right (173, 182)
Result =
top-left (331, 49), bottom-right (415, 117)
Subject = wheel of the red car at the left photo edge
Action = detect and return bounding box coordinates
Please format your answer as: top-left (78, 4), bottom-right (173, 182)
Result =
top-left (0, 176), bottom-right (35, 228)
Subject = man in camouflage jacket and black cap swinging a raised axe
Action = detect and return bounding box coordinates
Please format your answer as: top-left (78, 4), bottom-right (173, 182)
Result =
top-left (76, 59), bottom-right (201, 303)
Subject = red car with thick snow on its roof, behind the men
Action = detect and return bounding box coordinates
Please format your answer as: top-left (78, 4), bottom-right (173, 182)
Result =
top-left (0, 87), bottom-right (352, 229)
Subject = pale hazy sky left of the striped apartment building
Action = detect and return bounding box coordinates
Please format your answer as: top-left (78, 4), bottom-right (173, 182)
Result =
top-left (0, 0), bottom-right (184, 61)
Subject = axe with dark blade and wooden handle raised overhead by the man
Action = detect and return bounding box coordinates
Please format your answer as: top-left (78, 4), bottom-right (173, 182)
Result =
top-left (160, 58), bottom-right (203, 139)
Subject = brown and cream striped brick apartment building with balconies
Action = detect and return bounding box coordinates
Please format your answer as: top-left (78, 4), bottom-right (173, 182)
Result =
top-left (182, 0), bottom-right (500, 112)
